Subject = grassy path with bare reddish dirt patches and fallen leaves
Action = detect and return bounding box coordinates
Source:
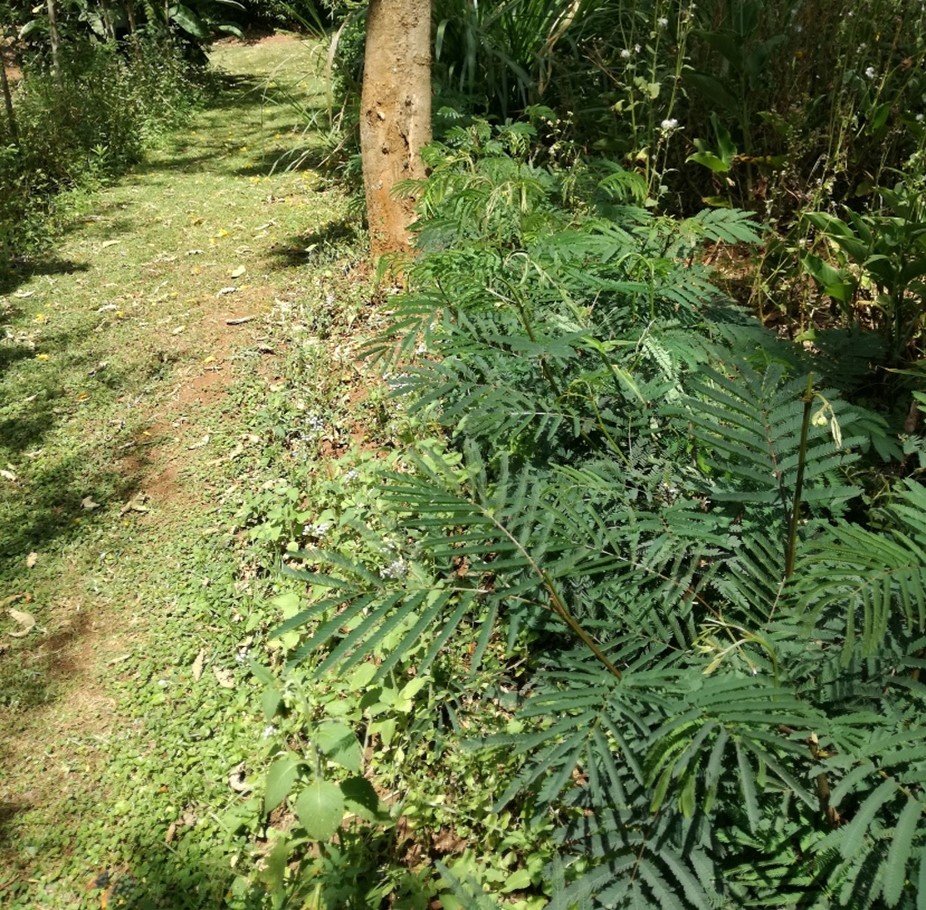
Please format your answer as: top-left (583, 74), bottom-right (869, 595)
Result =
top-left (0, 33), bottom-right (356, 910)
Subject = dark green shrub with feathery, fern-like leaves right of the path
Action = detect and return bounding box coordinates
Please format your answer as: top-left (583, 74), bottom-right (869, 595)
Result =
top-left (265, 123), bottom-right (926, 910)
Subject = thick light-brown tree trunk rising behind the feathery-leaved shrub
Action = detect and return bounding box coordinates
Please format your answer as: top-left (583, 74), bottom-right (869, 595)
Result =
top-left (360, 0), bottom-right (431, 256)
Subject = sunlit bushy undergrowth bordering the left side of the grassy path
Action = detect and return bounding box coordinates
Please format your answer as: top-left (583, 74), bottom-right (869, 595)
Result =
top-left (0, 32), bottom-right (203, 268)
